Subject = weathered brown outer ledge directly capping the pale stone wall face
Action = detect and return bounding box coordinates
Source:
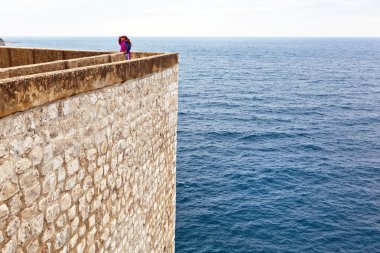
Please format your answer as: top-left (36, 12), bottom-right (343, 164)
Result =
top-left (0, 54), bottom-right (178, 118)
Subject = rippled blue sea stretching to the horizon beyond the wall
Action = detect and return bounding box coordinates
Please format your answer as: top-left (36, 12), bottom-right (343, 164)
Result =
top-left (7, 37), bottom-right (380, 253)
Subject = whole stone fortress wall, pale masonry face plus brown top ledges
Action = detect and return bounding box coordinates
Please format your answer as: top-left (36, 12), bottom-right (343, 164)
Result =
top-left (0, 47), bottom-right (178, 253)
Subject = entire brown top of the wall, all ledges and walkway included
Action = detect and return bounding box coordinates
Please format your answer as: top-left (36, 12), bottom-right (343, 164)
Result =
top-left (0, 47), bottom-right (178, 118)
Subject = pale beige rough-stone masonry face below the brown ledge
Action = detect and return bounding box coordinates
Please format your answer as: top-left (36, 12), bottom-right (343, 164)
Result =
top-left (0, 65), bottom-right (178, 253)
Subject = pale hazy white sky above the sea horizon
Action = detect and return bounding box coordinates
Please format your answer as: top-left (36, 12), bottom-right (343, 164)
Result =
top-left (0, 0), bottom-right (380, 37)
